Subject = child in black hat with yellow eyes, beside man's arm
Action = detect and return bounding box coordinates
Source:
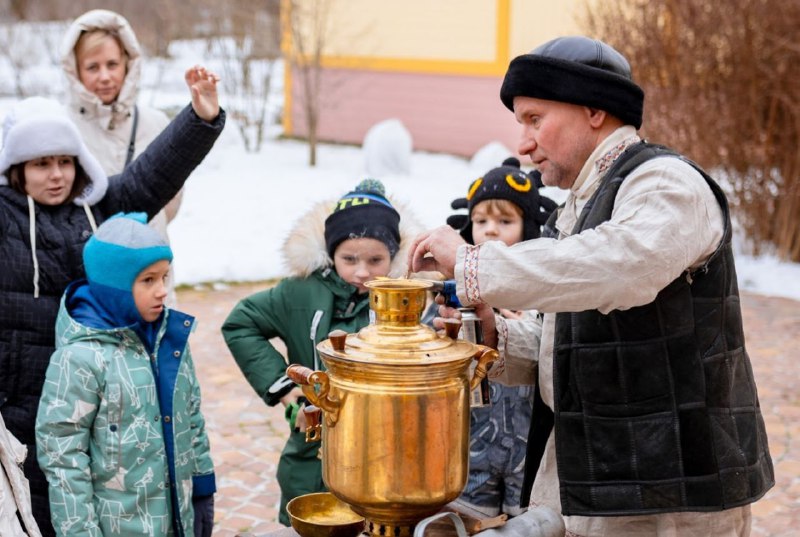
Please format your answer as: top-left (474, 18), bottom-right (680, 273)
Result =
top-left (440, 157), bottom-right (556, 516)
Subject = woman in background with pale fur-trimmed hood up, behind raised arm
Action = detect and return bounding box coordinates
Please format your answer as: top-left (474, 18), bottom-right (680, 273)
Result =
top-left (61, 9), bottom-right (181, 305)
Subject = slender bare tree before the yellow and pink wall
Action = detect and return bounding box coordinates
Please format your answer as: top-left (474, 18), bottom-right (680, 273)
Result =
top-left (283, 0), bottom-right (334, 166)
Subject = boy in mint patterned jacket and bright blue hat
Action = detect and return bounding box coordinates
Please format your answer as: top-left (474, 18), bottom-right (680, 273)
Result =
top-left (36, 213), bottom-right (216, 537)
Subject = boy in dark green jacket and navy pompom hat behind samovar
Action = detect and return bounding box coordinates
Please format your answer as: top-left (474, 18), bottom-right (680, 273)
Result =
top-left (222, 179), bottom-right (415, 526)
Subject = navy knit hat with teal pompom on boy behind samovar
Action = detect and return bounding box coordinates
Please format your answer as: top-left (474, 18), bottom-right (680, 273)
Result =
top-left (325, 179), bottom-right (400, 259)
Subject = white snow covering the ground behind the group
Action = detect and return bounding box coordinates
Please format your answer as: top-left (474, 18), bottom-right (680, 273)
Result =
top-left (0, 33), bottom-right (800, 300)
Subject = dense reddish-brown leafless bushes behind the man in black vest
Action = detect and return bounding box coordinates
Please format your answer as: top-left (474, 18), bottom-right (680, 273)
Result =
top-left (585, 0), bottom-right (800, 261)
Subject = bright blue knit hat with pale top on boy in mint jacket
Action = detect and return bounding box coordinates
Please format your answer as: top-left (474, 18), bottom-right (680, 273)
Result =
top-left (83, 213), bottom-right (172, 293)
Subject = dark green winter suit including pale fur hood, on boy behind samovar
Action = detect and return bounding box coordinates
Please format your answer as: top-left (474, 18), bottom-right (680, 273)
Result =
top-left (222, 194), bottom-right (419, 525)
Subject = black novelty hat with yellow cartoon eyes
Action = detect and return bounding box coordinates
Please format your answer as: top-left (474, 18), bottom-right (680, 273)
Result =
top-left (447, 157), bottom-right (556, 243)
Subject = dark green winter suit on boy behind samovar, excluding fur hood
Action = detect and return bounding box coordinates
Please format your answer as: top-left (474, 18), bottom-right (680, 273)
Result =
top-left (222, 269), bottom-right (369, 525)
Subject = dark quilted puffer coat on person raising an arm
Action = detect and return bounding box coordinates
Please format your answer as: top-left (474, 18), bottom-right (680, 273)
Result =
top-left (0, 106), bottom-right (225, 534)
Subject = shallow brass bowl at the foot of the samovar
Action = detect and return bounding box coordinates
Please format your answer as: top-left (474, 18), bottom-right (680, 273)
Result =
top-left (286, 492), bottom-right (364, 537)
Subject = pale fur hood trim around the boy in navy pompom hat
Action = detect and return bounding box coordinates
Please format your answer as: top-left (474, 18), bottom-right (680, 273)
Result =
top-left (281, 196), bottom-right (424, 278)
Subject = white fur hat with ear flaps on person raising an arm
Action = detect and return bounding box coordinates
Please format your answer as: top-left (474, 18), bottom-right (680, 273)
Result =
top-left (0, 97), bottom-right (108, 205)
